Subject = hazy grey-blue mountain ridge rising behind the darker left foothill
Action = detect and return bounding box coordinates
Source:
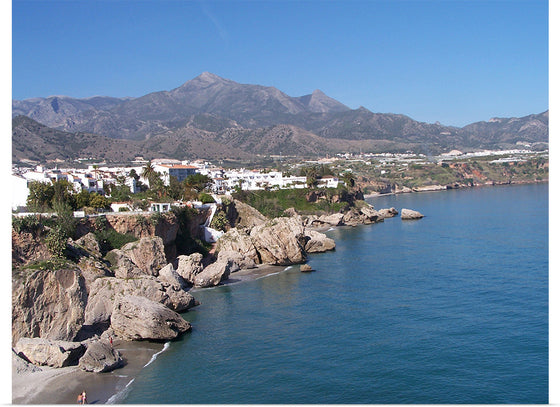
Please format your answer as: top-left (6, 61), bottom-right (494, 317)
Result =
top-left (12, 72), bottom-right (548, 159)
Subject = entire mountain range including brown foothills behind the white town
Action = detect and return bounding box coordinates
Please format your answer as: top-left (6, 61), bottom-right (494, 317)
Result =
top-left (12, 72), bottom-right (548, 161)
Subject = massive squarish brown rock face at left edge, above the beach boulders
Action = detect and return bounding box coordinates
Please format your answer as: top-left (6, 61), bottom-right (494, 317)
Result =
top-left (12, 268), bottom-right (87, 343)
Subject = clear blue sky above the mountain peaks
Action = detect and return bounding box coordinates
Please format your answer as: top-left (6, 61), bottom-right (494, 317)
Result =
top-left (12, 0), bottom-right (548, 126)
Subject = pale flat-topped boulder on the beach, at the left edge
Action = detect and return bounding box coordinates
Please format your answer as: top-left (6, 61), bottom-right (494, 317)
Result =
top-left (14, 338), bottom-right (85, 367)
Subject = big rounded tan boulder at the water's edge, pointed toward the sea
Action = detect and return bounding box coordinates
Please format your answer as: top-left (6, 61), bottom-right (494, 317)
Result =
top-left (111, 296), bottom-right (191, 341)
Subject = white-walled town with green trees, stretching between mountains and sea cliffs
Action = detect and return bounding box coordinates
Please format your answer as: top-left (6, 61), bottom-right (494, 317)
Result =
top-left (11, 148), bottom-right (548, 217)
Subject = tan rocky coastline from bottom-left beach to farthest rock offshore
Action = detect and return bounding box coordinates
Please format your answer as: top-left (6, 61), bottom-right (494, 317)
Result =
top-left (12, 202), bottom-right (416, 402)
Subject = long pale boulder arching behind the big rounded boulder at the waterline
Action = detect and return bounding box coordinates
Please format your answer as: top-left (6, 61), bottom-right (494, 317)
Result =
top-left (84, 276), bottom-right (198, 325)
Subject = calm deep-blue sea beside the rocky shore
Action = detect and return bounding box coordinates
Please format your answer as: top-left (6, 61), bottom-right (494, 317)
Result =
top-left (122, 185), bottom-right (548, 404)
